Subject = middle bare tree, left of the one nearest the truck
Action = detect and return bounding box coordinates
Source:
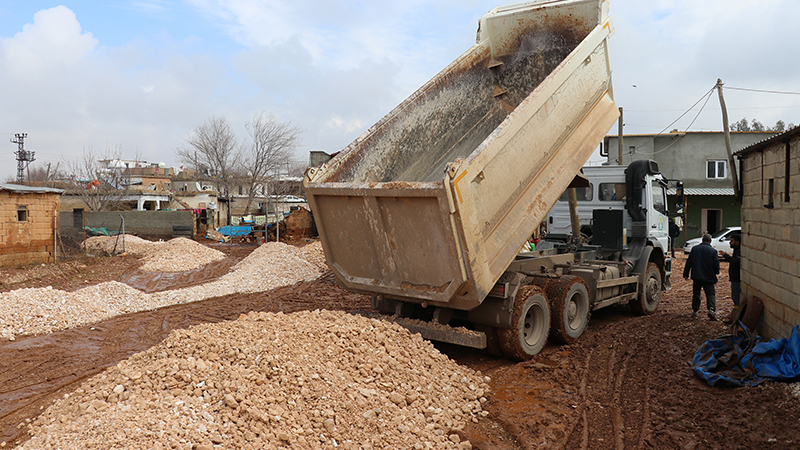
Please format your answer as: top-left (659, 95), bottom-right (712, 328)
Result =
top-left (180, 116), bottom-right (240, 223)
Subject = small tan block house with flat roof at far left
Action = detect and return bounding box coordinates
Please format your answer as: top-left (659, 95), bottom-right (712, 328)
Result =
top-left (0, 184), bottom-right (64, 267)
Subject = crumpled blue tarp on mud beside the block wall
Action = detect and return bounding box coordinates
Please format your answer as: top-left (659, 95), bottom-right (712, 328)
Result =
top-left (692, 322), bottom-right (800, 386)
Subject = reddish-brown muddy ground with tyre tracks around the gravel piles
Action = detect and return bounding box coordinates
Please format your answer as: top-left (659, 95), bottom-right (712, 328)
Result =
top-left (0, 242), bottom-right (800, 450)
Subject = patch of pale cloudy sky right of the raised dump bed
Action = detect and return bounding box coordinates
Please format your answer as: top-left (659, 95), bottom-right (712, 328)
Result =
top-left (611, 0), bottom-right (800, 134)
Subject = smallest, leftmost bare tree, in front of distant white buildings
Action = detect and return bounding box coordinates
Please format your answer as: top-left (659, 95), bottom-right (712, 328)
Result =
top-left (65, 146), bottom-right (130, 211)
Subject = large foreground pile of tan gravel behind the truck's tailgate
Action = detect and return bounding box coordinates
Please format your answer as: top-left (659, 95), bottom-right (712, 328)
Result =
top-left (20, 311), bottom-right (489, 450)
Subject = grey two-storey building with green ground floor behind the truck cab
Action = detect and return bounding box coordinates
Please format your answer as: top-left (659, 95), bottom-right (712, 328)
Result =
top-left (601, 130), bottom-right (777, 247)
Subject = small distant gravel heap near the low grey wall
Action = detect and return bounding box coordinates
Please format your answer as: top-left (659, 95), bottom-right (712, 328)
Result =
top-left (82, 234), bottom-right (225, 272)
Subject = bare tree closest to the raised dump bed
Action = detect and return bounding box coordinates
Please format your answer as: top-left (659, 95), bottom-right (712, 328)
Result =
top-left (241, 112), bottom-right (300, 214)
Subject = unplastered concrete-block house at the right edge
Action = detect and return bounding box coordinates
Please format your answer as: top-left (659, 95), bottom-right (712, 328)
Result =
top-left (736, 127), bottom-right (800, 339)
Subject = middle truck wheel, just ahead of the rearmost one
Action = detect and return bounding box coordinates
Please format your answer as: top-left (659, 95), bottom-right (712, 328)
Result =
top-left (547, 275), bottom-right (589, 344)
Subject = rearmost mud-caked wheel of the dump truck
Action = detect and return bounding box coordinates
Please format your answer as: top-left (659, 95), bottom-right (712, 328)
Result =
top-left (497, 286), bottom-right (550, 361)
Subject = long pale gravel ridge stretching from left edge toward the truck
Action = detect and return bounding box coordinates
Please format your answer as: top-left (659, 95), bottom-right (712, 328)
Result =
top-left (0, 243), bottom-right (327, 340)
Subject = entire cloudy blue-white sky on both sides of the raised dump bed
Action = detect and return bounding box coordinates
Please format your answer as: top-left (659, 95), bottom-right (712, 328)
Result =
top-left (0, 0), bottom-right (800, 181)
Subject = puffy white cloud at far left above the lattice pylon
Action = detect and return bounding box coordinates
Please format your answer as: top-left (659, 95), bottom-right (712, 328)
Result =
top-left (0, 6), bottom-right (234, 175)
